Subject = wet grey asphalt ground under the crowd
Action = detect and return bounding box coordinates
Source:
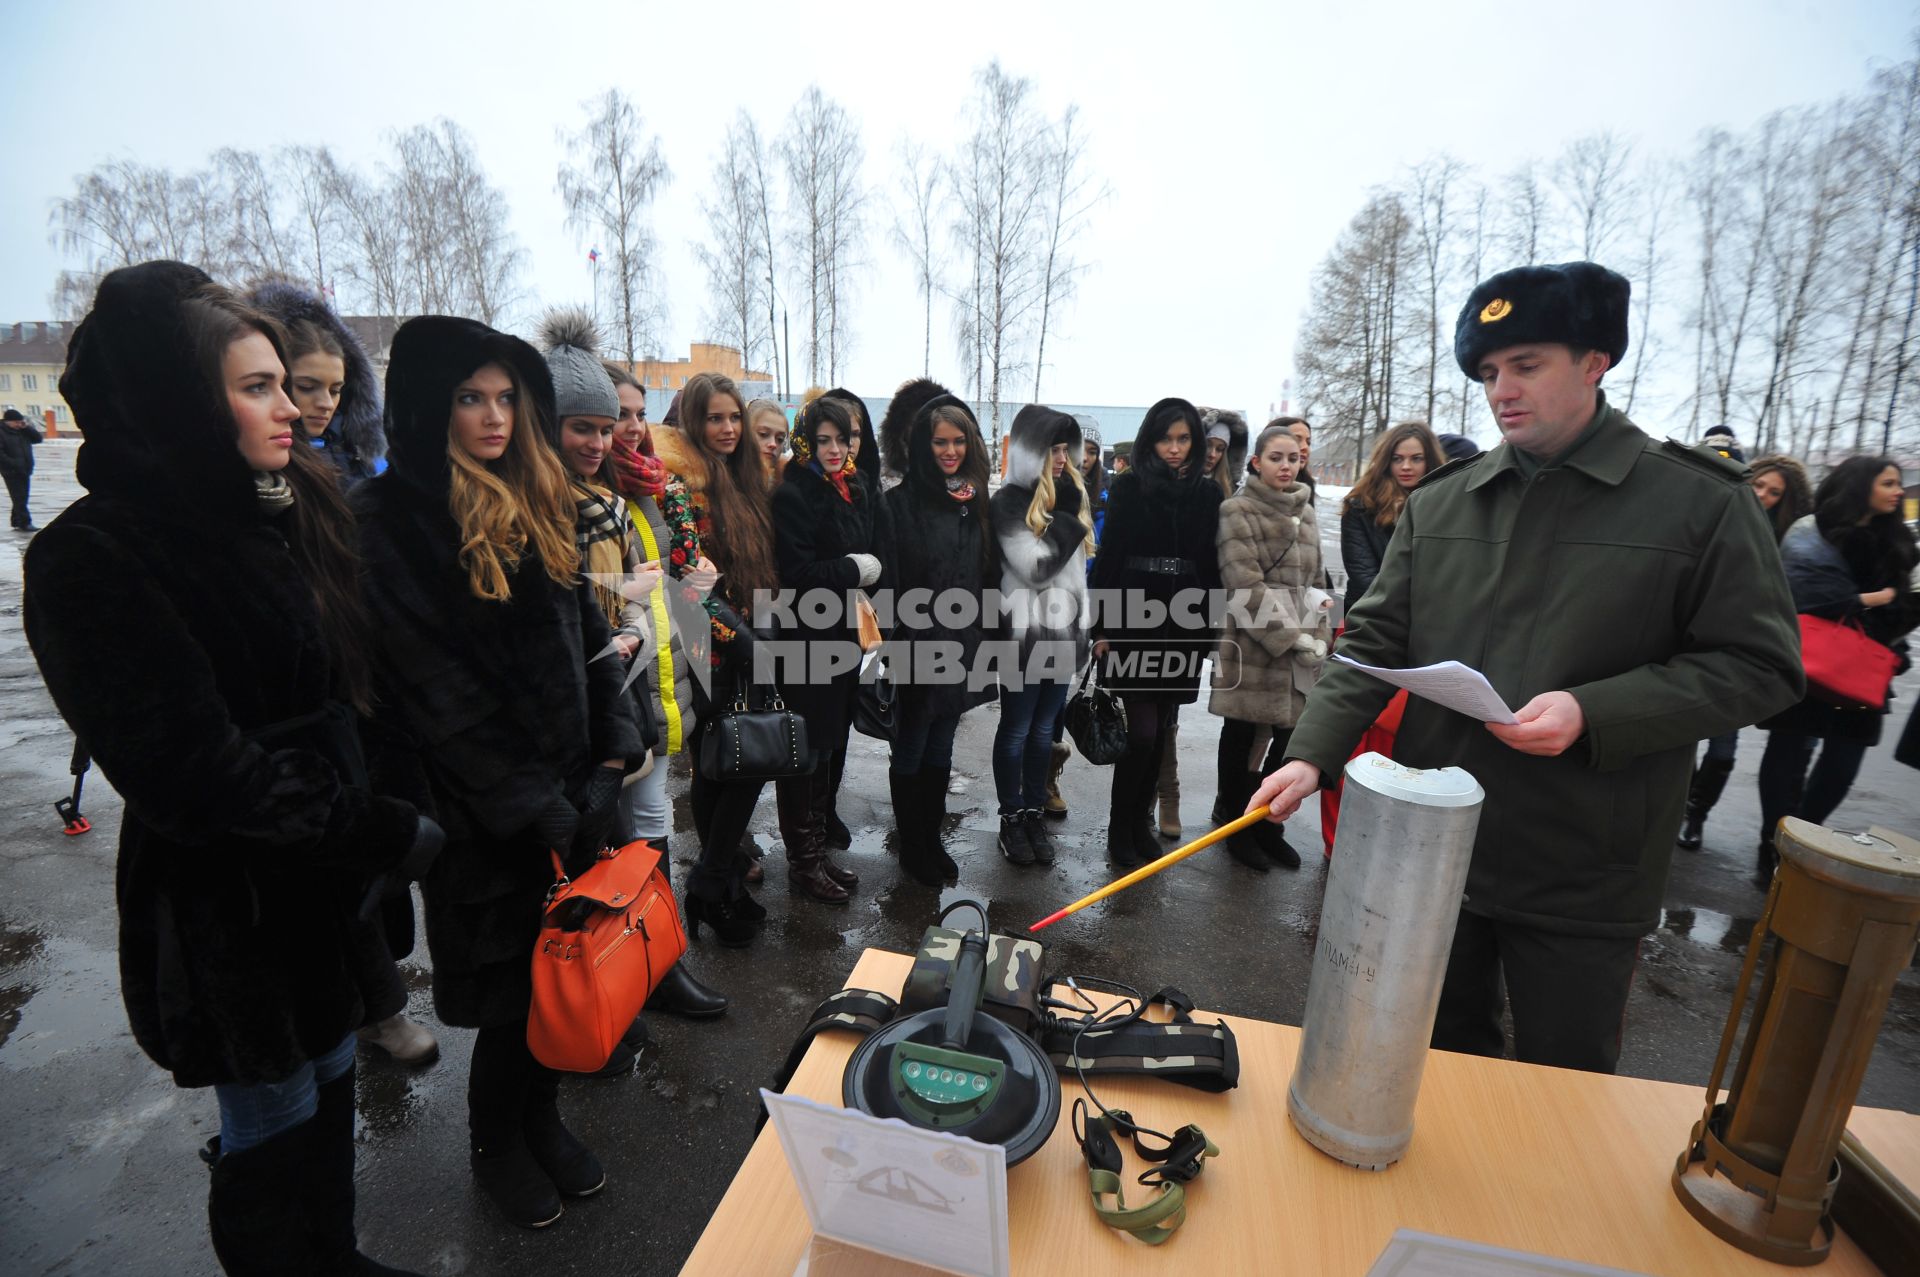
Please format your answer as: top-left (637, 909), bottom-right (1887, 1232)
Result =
top-left (0, 444), bottom-right (1920, 1277)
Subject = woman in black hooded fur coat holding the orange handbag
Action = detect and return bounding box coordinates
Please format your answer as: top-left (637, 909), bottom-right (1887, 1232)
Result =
top-left (353, 315), bottom-right (645, 1227)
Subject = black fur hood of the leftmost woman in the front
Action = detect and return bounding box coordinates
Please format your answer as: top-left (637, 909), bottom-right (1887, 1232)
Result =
top-left (60, 261), bottom-right (259, 522)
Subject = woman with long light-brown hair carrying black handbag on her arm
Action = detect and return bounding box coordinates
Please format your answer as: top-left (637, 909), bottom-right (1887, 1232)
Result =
top-left (653, 373), bottom-right (780, 949)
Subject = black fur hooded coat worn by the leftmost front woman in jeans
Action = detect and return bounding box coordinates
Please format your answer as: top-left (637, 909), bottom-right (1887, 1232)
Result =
top-left (25, 261), bottom-right (419, 1087)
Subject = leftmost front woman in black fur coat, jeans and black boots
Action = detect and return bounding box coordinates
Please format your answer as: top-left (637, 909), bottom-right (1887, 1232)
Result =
top-left (25, 261), bottom-right (438, 1273)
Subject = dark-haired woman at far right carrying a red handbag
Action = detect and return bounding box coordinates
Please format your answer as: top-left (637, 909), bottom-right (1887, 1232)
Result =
top-left (1753, 457), bottom-right (1920, 887)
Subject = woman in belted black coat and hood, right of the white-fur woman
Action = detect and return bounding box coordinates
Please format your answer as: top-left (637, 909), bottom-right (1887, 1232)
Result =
top-left (1092, 399), bottom-right (1221, 866)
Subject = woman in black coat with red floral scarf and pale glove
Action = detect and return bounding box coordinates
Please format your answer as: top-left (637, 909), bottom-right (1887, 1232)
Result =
top-left (774, 398), bottom-right (879, 904)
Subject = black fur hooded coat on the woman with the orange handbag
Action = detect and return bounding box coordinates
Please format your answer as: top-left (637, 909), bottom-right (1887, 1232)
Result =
top-left (353, 315), bottom-right (645, 1027)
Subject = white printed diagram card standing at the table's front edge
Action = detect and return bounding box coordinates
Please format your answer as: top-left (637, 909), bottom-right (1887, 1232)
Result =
top-left (760, 1091), bottom-right (1010, 1277)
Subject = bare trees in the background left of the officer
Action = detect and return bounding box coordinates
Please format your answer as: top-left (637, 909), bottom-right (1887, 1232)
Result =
top-left (50, 61), bottom-right (1106, 438)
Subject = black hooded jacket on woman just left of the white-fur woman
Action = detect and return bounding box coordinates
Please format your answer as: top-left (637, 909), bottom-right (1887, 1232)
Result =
top-left (881, 392), bottom-right (1000, 716)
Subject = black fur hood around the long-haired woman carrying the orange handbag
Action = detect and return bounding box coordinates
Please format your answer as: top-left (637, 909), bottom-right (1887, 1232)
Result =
top-left (386, 315), bottom-right (553, 501)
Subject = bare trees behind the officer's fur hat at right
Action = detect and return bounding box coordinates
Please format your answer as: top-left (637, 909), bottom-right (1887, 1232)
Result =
top-left (1296, 42), bottom-right (1920, 483)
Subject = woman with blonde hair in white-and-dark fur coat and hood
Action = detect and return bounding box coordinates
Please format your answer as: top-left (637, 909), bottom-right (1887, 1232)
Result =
top-left (993, 403), bottom-right (1092, 864)
